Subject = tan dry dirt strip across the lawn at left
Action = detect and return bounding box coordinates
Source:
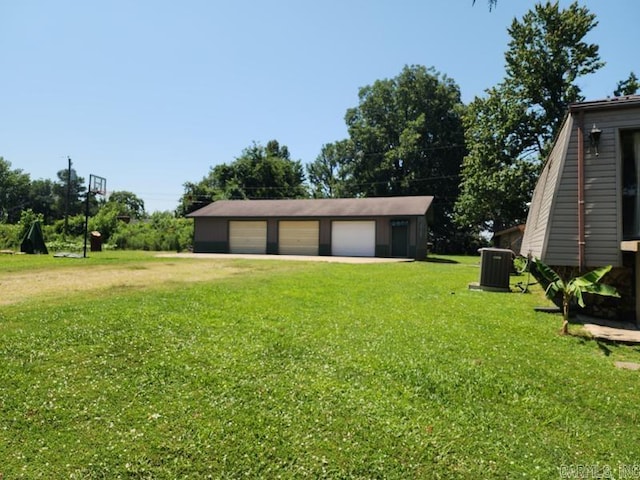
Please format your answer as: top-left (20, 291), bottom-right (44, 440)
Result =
top-left (0, 260), bottom-right (246, 305)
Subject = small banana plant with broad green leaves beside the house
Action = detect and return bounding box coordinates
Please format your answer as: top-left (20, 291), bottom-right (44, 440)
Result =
top-left (534, 258), bottom-right (620, 335)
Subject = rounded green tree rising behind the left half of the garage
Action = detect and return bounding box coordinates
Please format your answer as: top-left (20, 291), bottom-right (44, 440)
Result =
top-left (178, 140), bottom-right (308, 215)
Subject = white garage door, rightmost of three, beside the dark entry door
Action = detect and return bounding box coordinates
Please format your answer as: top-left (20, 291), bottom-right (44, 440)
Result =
top-left (331, 220), bottom-right (376, 257)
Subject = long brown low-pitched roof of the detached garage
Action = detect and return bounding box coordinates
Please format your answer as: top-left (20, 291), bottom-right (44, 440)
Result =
top-left (187, 196), bottom-right (433, 218)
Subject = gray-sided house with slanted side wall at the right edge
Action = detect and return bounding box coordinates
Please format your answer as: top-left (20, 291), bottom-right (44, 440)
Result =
top-left (520, 95), bottom-right (640, 320)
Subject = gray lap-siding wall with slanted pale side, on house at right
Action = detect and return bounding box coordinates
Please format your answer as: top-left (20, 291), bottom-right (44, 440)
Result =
top-left (520, 96), bottom-right (640, 267)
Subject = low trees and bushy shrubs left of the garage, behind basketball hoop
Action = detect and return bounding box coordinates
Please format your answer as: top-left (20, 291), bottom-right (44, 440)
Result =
top-left (0, 157), bottom-right (193, 251)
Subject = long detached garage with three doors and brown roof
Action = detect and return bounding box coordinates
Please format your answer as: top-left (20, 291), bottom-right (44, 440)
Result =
top-left (188, 196), bottom-right (433, 260)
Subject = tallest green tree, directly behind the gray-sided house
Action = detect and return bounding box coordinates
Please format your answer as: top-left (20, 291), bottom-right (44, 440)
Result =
top-left (456, 2), bottom-right (603, 232)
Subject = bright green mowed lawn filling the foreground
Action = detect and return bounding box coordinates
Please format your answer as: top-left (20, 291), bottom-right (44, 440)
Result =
top-left (0, 255), bottom-right (640, 479)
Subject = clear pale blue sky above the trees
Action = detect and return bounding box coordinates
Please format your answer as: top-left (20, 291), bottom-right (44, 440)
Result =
top-left (0, 0), bottom-right (640, 211)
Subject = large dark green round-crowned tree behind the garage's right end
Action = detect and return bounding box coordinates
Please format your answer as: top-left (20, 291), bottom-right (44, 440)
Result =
top-left (345, 65), bottom-right (465, 246)
